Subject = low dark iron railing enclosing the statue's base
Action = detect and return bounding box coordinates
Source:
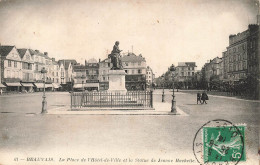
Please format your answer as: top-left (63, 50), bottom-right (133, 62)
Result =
top-left (71, 91), bottom-right (153, 109)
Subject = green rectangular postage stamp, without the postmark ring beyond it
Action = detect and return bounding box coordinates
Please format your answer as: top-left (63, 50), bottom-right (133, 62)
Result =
top-left (203, 125), bottom-right (246, 163)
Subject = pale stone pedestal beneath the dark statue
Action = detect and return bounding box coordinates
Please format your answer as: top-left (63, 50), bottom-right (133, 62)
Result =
top-left (107, 70), bottom-right (127, 94)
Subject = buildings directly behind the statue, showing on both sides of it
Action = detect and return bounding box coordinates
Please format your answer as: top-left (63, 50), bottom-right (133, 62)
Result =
top-left (73, 53), bottom-right (154, 90)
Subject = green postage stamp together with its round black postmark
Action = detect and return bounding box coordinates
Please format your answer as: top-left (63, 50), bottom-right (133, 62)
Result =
top-left (193, 119), bottom-right (246, 164)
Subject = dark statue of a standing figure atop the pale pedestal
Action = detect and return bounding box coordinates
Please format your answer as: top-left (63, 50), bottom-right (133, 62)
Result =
top-left (108, 41), bottom-right (123, 70)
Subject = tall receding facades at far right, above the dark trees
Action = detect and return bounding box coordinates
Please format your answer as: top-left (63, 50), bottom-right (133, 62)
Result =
top-left (201, 24), bottom-right (260, 94)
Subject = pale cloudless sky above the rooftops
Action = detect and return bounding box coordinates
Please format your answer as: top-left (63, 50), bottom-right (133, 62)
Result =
top-left (0, 0), bottom-right (258, 76)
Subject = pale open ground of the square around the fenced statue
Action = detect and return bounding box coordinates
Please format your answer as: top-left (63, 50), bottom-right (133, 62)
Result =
top-left (0, 90), bottom-right (260, 165)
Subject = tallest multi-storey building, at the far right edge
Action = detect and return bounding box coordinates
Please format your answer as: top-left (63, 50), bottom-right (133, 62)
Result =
top-left (223, 24), bottom-right (260, 98)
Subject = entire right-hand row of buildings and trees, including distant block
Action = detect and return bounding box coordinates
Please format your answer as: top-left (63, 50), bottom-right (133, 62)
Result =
top-left (156, 22), bottom-right (260, 99)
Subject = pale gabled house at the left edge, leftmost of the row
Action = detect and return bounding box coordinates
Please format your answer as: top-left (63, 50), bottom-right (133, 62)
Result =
top-left (0, 46), bottom-right (22, 91)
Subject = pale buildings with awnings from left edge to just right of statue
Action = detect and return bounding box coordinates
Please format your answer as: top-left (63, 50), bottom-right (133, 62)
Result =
top-left (0, 45), bottom-right (154, 92)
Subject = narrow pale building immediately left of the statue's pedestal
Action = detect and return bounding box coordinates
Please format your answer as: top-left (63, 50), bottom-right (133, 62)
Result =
top-left (99, 58), bottom-right (113, 90)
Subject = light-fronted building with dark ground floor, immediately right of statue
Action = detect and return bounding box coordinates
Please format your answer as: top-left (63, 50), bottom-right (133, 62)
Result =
top-left (121, 53), bottom-right (146, 90)
